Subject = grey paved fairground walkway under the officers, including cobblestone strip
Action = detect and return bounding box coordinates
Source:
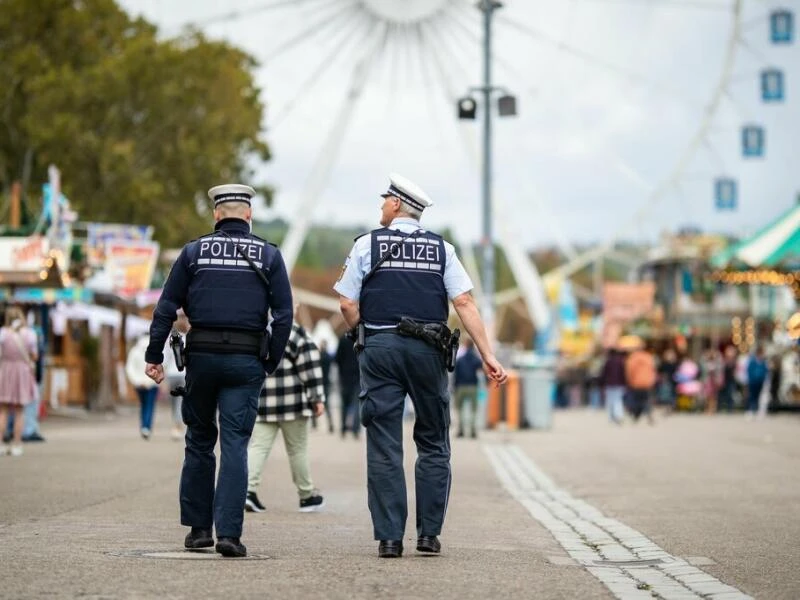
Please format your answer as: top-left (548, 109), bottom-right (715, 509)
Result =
top-left (0, 410), bottom-right (800, 600)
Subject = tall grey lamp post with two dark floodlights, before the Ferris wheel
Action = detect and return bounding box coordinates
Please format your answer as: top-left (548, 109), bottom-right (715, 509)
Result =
top-left (458, 0), bottom-right (516, 338)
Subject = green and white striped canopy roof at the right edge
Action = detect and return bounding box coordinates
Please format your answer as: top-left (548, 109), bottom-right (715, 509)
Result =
top-left (711, 203), bottom-right (800, 267)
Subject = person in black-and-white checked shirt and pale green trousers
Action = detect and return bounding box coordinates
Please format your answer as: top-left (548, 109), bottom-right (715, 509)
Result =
top-left (245, 321), bottom-right (325, 512)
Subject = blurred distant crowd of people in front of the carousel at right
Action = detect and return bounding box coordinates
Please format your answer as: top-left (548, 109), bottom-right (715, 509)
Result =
top-left (555, 336), bottom-right (800, 423)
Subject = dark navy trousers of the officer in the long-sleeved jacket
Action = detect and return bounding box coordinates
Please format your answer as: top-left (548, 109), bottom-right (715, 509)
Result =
top-left (180, 352), bottom-right (265, 538)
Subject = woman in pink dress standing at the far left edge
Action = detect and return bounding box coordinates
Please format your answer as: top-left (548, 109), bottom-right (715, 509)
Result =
top-left (0, 306), bottom-right (38, 456)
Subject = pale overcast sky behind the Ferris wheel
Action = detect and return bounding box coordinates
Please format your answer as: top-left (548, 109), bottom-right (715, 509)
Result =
top-left (121, 0), bottom-right (800, 247)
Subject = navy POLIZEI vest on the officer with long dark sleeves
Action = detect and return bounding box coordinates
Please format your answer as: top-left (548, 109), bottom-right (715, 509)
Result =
top-left (185, 219), bottom-right (278, 332)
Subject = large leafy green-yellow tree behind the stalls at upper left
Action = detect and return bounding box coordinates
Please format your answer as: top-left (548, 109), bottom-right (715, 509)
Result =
top-left (0, 0), bottom-right (269, 245)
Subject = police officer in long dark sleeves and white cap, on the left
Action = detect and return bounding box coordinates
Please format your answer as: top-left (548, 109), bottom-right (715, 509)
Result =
top-left (145, 184), bottom-right (293, 557)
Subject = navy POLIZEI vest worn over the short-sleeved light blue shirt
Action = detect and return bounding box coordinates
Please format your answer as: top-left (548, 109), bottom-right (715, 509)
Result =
top-left (359, 227), bottom-right (448, 325)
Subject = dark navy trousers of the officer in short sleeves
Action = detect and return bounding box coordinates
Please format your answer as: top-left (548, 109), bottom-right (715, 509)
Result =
top-left (359, 333), bottom-right (450, 540)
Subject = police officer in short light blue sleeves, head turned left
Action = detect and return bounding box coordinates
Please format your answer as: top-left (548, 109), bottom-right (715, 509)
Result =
top-left (334, 174), bottom-right (507, 558)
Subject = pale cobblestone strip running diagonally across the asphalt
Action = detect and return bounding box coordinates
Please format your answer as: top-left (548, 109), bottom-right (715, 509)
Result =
top-left (484, 444), bottom-right (753, 600)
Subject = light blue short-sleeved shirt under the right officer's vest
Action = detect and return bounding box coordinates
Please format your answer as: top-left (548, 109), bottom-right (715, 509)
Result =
top-left (333, 218), bottom-right (473, 326)
